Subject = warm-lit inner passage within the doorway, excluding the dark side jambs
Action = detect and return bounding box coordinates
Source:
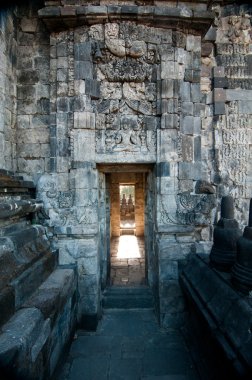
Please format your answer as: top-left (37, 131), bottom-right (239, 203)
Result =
top-left (110, 172), bottom-right (146, 286)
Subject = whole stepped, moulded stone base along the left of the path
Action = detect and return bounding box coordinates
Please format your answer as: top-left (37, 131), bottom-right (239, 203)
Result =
top-left (0, 170), bottom-right (77, 379)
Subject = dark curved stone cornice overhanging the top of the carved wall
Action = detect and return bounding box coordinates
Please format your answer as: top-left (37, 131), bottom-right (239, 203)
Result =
top-left (38, 5), bottom-right (214, 35)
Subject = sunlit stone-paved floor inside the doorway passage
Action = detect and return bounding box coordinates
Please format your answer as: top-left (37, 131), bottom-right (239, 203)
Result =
top-left (110, 235), bottom-right (146, 286)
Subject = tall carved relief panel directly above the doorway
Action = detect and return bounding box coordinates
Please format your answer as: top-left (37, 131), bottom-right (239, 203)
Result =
top-left (84, 22), bottom-right (159, 161)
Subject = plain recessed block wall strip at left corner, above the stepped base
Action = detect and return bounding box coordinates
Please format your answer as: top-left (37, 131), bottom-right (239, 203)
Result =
top-left (16, 1), bottom-right (53, 182)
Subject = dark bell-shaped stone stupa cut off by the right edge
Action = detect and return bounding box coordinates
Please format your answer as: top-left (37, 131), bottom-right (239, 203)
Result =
top-left (232, 200), bottom-right (252, 294)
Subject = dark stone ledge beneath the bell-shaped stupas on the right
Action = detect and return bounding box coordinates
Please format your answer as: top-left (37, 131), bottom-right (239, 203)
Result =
top-left (180, 255), bottom-right (252, 378)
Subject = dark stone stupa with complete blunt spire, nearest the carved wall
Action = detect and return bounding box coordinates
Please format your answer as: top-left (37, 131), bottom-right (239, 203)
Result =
top-left (210, 196), bottom-right (242, 271)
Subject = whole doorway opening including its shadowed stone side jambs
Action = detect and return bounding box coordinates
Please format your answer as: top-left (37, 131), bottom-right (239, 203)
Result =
top-left (98, 164), bottom-right (153, 288)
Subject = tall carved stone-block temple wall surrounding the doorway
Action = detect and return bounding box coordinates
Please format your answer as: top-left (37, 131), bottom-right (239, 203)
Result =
top-left (0, 0), bottom-right (252, 326)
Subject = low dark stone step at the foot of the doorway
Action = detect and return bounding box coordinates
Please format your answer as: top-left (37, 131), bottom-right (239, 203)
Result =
top-left (102, 286), bottom-right (154, 309)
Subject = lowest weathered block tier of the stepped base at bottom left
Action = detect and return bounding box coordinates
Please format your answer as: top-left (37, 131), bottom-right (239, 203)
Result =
top-left (0, 267), bottom-right (77, 380)
